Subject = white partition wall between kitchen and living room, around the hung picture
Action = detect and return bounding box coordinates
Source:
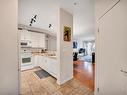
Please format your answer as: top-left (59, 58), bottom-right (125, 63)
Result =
top-left (57, 9), bottom-right (73, 84)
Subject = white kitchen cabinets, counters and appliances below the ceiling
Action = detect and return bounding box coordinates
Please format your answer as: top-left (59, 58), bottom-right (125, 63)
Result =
top-left (18, 25), bottom-right (57, 79)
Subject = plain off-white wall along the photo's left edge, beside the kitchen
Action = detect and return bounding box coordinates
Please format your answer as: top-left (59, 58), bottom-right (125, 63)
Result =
top-left (0, 0), bottom-right (18, 95)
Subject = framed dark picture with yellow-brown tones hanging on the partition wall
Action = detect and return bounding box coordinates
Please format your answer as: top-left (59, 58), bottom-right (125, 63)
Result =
top-left (64, 26), bottom-right (71, 42)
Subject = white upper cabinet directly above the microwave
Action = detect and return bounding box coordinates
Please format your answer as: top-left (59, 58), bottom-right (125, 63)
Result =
top-left (19, 30), bottom-right (31, 41)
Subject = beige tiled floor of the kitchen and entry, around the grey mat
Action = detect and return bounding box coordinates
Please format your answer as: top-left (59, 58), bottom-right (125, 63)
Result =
top-left (21, 68), bottom-right (93, 95)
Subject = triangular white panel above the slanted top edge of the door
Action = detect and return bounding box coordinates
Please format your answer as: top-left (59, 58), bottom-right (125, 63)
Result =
top-left (95, 0), bottom-right (120, 20)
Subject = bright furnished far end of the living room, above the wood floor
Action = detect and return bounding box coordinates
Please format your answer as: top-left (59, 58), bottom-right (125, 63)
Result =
top-left (73, 40), bottom-right (95, 63)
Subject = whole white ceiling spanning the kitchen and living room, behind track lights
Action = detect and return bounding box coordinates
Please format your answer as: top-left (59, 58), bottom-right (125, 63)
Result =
top-left (18, 0), bottom-right (94, 39)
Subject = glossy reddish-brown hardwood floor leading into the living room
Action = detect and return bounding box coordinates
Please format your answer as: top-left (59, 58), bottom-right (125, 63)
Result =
top-left (74, 60), bottom-right (95, 91)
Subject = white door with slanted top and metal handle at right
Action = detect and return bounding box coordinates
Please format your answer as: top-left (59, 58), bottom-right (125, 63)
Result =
top-left (97, 0), bottom-right (127, 95)
